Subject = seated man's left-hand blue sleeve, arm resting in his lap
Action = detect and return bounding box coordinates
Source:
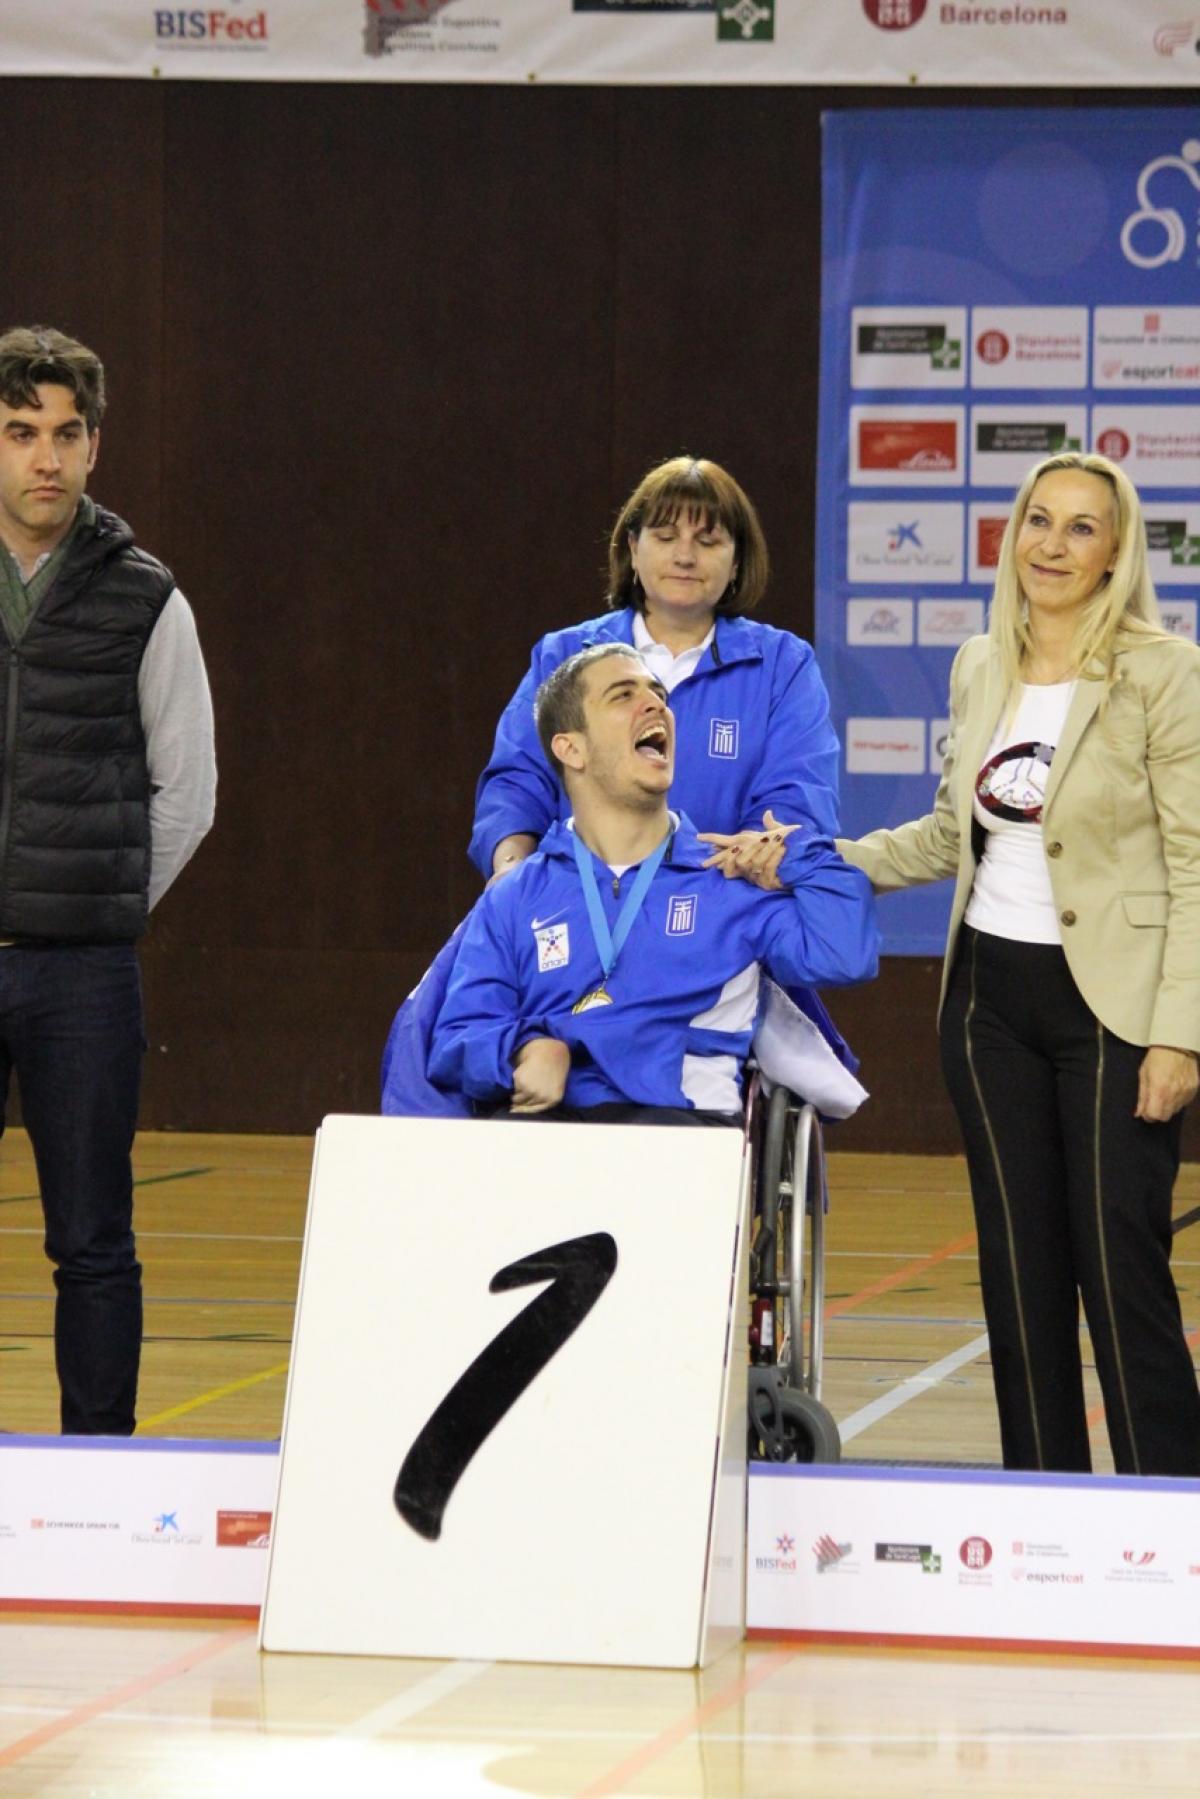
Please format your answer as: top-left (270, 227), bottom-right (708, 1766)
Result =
top-left (428, 874), bottom-right (552, 1099)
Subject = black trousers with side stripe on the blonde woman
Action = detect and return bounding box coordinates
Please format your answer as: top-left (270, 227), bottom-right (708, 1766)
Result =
top-left (941, 926), bottom-right (1200, 1475)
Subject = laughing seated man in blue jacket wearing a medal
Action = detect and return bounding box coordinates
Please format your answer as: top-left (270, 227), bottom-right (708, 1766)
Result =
top-left (428, 644), bottom-right (878, 1124)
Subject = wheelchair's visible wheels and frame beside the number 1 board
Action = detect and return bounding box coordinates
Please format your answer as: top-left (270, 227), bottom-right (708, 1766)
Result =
top-left (747, 1072), bottom-right (842, 1463)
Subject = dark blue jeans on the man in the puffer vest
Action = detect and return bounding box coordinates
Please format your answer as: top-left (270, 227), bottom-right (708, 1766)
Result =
top-left (0, 943), bottom-right (146, 1436)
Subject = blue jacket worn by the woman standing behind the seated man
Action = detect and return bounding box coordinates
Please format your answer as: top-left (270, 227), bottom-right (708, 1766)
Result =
top-left (470, 606), bottom-right (838, 876)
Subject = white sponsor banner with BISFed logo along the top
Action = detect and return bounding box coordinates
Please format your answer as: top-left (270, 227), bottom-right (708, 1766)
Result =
top-left (0, 0), bottom-right (1200, 90)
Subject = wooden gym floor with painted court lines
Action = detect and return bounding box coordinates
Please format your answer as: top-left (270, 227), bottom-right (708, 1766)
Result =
top-left (0, 1132), bottom-right (1200, 1799)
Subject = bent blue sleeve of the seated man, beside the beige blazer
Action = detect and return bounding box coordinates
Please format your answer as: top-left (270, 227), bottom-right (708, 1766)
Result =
top-left (759, 831), bottom-right (880, 988)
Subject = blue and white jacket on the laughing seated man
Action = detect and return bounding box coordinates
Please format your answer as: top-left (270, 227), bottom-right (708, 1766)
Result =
top-left (428, 817), bottom-right (878, 1112)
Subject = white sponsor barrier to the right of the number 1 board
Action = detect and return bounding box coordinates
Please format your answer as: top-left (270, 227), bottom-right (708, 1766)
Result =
top-left (747, 1463), bottom-right (1200, 1659)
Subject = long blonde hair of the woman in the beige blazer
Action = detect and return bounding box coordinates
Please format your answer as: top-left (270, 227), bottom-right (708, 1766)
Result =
top-left (988, 450), bottom-right (1169, 694)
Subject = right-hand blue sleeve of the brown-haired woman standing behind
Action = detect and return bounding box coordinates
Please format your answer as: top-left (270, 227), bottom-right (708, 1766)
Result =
top-left (737, 631), bottom-right (842, 838)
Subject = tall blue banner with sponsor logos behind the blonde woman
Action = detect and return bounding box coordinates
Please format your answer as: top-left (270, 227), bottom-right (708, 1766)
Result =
top-left (817, 108), bottom-right (1200, 955)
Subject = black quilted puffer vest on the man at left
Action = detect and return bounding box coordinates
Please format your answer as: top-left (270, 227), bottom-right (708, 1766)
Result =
top-left (0, 507), bottom-right (175, 943)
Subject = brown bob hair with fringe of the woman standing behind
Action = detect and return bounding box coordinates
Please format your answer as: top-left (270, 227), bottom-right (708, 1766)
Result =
top-left (608, 455), bottom-right (770, 617)
